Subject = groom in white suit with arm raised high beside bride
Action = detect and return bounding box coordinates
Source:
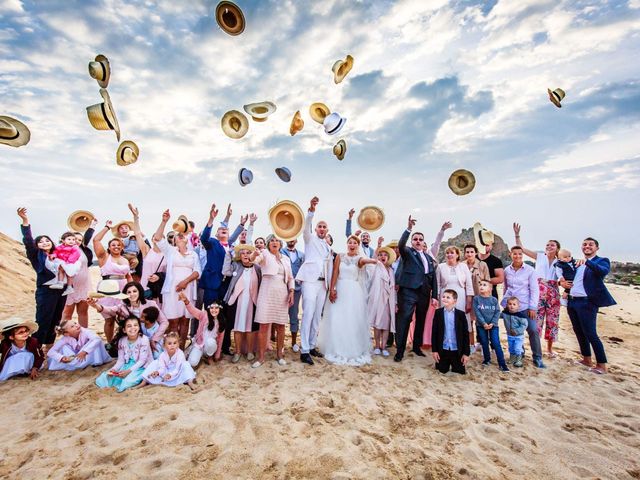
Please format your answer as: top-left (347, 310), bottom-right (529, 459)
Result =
top-left (296, 197), bottom-right (332, 365)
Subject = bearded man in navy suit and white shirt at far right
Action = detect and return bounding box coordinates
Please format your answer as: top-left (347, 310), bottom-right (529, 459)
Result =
top-left (560, 237), bottom-right (616, 373)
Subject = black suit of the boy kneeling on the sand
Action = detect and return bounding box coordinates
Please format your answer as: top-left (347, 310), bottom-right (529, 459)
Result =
top-left (431, 307), bottom-right (471, 374)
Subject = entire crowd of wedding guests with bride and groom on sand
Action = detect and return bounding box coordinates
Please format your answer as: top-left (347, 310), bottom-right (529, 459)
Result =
top-left (0, 197), bottom-right (615, 391)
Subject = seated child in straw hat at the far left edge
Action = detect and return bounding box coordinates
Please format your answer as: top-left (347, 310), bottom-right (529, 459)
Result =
top-left (0, 318), bottom-right (44, 382)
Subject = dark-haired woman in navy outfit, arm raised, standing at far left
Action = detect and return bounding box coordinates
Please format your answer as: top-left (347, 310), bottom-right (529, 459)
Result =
top-left (18, 207), bottom-right (66, 348)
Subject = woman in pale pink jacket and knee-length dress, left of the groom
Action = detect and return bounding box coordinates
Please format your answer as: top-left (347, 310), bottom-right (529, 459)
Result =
top-left (252, 235), bottom-right (295, 368)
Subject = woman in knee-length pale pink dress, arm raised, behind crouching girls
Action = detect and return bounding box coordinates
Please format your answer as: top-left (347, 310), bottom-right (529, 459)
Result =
top-left (153, 210), bottom-right (202, 349)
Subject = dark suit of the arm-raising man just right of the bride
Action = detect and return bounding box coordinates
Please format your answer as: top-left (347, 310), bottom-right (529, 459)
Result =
top-left (396, 230), bottom-right (438, 359)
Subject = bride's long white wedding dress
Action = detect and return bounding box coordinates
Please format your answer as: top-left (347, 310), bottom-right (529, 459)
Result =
top-left (318, 254), bottom-right (371, 366)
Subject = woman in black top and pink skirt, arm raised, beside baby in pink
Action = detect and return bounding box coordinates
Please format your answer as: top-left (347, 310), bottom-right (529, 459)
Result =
top-left (62, 218), bottom-right (98, 328)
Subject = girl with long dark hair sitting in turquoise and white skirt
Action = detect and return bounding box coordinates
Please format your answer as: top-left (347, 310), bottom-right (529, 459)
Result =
top-left (96, 317), bottom-right (153, 393)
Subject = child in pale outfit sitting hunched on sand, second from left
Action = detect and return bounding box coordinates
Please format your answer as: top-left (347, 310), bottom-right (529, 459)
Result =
top-left (47, 320), bottom-right (112, 370)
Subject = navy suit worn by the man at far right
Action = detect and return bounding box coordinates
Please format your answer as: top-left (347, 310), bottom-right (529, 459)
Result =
top-left (567, 256), bottom-right (616, 363)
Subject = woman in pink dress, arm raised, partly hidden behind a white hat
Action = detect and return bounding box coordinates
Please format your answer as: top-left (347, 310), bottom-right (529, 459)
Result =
top-left (93, 220), bottom-right (132, 342)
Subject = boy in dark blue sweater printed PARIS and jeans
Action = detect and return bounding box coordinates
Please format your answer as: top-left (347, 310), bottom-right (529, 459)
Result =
top-left (473, 279), bottom-right (509, 372)
